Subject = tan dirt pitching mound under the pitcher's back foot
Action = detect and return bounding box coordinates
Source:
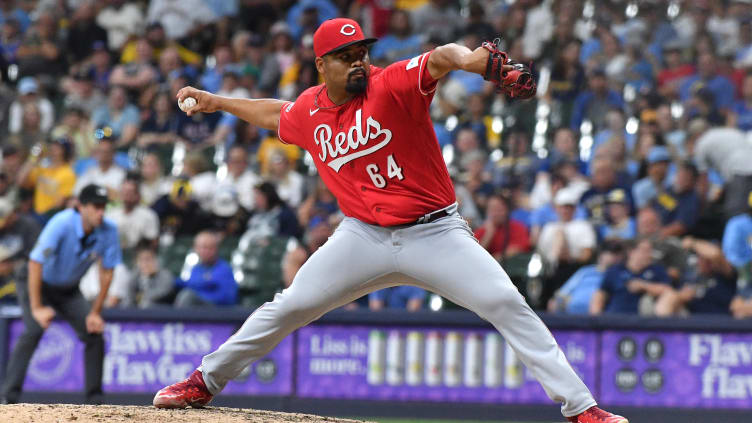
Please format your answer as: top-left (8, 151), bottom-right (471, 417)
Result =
top-left (0, 404), bottom-right (376, 423)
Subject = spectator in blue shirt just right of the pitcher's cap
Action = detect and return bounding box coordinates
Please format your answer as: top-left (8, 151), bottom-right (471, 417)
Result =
top-left (371, 9), bottom-right (423, 63)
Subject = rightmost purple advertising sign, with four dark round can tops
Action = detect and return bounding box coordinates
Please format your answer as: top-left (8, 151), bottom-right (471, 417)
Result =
top-left (600, 331), bottom-right (752, 408)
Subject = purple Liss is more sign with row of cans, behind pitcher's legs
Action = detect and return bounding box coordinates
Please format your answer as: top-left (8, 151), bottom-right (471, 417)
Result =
top-left (297, 325), bottom-right (597, 404)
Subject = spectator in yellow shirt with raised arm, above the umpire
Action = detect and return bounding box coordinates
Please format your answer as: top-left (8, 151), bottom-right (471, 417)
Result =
top-left (19, 138), bottom-right (76, 217)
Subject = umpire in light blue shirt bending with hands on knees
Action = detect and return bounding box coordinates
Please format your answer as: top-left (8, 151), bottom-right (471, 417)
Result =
top-left (2, 184), bottom-right (121, 403)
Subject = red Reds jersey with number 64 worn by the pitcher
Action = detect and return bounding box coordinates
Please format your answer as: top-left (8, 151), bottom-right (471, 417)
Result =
top-left (279, 52), bottom-right (455, 226)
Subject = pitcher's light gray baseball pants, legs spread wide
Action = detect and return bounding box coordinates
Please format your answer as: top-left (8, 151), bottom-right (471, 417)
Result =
top-left (199, 212), bottom-right (595, 416)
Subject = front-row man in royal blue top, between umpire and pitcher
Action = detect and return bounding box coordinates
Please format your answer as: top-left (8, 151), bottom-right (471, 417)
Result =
top-left (175, 231), bottom-right (238, 307)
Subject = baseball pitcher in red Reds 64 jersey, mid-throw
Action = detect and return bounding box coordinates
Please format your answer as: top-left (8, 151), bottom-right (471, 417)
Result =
top-left (154, 18), bottom-right (628, 423)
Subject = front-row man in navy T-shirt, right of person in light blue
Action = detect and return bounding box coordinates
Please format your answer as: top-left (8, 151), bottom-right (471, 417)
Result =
top-left (590, 239), bottom-right (676, 316)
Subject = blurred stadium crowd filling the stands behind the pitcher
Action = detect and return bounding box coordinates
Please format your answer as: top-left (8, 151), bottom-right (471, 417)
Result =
top-left (0, 0), bottom-right (752, 318)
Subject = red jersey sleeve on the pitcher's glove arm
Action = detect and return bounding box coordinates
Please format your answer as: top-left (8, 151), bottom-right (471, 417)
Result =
top-left (384, 51), bottom-right (438, 117)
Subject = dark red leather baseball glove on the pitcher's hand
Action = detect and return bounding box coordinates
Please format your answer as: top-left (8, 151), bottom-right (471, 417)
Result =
top-left (483, 38), bottom-right (536, 99)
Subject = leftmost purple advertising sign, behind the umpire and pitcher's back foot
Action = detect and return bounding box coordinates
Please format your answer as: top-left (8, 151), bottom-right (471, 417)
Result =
top-left (10, 320), bottom-right (293, 395)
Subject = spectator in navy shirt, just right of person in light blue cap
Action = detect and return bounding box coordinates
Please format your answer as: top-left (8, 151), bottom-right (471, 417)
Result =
top-left (651, 162), bottom-right (700, 238)
